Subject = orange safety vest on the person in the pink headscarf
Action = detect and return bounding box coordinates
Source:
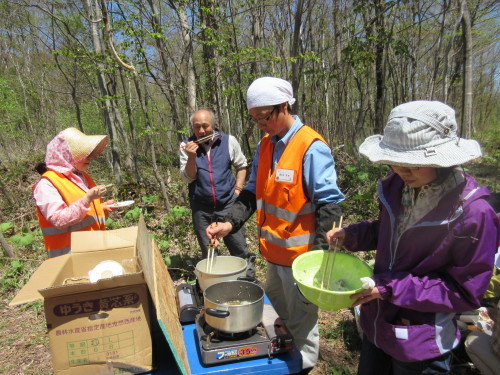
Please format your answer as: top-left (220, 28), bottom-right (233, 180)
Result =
top-left (35, 170), bottom-right (106, 258)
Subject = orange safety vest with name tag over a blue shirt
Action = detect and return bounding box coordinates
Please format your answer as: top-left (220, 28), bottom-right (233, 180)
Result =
top-left (256, 125), bottom-right (326, 266)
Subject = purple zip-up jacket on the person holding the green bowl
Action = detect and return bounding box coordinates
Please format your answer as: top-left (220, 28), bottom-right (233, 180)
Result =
top-left (344, 173), bottom-right (499, 362)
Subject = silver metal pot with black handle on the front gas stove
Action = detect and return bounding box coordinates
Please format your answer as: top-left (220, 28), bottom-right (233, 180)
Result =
top-left (203, 280), bottom-right (264, 333)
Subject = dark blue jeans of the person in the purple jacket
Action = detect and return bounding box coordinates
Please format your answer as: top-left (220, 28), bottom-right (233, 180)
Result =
top-left (358, 335), bottom-right (452, 375)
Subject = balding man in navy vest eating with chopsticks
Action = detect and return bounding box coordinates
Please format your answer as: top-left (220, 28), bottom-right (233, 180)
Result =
top-left (180, 109), bottom-right (252, 268)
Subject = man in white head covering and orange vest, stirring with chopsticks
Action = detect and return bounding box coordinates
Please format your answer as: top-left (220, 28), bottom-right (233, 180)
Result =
top-left (207, 77), bottom-right (344, 373)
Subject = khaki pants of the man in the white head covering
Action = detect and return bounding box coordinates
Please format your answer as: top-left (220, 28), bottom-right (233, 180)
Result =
top-left (265, 262), bottom-right (319, 369)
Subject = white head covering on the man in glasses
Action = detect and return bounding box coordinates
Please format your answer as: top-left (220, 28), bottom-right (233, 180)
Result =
top-left (247, 77), bottom-right (295, 109)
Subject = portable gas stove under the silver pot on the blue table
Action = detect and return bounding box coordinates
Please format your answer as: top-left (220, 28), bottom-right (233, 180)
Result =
top-left (177, 284), bottom-right (294, 365)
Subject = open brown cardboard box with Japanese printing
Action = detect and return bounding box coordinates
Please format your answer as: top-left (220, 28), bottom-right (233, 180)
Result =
top-left (10, 225), bottom-right (152, 375)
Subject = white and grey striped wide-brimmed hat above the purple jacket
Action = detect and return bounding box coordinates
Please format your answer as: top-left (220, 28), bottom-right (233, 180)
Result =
top-left (359, 100), bottom-right (482, 168)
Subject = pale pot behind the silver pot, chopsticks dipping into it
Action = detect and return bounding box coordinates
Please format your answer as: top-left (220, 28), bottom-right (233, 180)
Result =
top-left (194, 256), bottom-right (247, 291)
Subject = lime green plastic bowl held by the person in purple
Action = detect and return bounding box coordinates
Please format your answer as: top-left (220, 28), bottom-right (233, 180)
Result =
top-left (292, 250), bottom-right (373, 311)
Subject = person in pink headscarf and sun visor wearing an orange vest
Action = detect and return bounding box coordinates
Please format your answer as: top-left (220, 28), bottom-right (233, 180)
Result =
top-left (33, 128), bottom-right (114, 258)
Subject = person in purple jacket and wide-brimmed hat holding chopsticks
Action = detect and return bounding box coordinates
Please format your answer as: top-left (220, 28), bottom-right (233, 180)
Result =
top-left (327, 101), bottom-right (499, 375)
